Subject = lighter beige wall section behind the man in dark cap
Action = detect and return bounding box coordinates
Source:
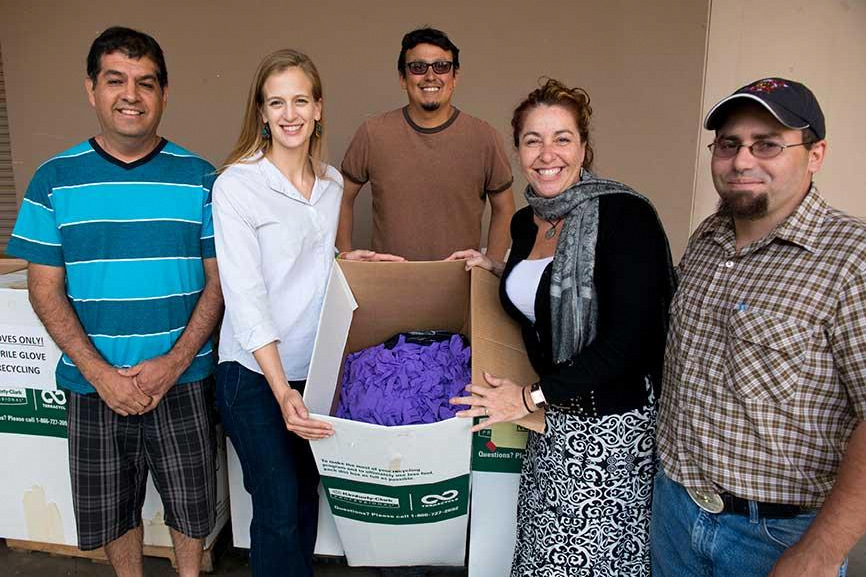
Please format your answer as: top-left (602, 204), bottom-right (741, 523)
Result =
top-left (691, 0), bottom-right (866, 229)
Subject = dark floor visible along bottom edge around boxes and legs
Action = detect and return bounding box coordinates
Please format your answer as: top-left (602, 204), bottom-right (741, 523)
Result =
top-left (0, 539), bottom-right (866, 577)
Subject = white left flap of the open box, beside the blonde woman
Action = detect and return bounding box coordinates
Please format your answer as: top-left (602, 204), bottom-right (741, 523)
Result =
top-left (304, 266), bottom-right (358, 415)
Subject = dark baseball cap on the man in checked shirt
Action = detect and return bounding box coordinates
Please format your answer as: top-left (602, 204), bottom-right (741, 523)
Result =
top-left (704, 78), bottom-right (827, 140)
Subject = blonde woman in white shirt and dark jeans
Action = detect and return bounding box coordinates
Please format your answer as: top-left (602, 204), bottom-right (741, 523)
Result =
top-left (213, 50), bottom-right (400, 577)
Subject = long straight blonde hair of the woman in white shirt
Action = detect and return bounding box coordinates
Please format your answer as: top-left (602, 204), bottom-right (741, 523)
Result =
top-left (219, 48), bottom-right (327, 177)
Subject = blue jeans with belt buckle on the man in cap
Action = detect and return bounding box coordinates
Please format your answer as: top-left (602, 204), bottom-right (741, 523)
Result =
top-left (650, 467), bottom-right (848, 577)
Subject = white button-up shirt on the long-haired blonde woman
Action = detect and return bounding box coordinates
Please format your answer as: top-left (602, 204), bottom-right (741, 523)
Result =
top-left (213, 155), bottom-right (343, 380)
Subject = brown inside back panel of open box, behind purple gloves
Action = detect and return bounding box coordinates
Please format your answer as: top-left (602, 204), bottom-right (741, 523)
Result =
top-left (340, 261), bottom-right (469, 358)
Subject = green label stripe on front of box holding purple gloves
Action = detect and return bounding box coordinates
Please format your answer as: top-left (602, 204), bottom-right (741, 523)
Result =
top-left (322, 475), bottom-right (469, 525)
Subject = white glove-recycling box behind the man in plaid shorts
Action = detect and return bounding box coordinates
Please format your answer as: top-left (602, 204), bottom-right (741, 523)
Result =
top-left (0, 271), bottom-right (229, 547)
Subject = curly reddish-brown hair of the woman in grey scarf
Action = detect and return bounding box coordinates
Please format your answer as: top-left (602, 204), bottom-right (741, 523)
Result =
top-left (511, 77), bottom-right (595, 170)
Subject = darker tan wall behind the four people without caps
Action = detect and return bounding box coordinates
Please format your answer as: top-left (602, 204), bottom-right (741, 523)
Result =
top-left (0, 0), bottom-right (709, 255)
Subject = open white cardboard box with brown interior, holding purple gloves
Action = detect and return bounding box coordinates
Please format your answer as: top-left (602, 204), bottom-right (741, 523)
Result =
top-left (304, 261), bottom-right (534, 566)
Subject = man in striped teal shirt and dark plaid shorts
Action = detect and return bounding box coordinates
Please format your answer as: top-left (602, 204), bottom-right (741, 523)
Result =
top-left (7, 28), bottom-right (222, 575)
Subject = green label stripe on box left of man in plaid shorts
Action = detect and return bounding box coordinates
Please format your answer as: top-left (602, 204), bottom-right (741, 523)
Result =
top-left (0, 387), bottom-right (66, 439)
